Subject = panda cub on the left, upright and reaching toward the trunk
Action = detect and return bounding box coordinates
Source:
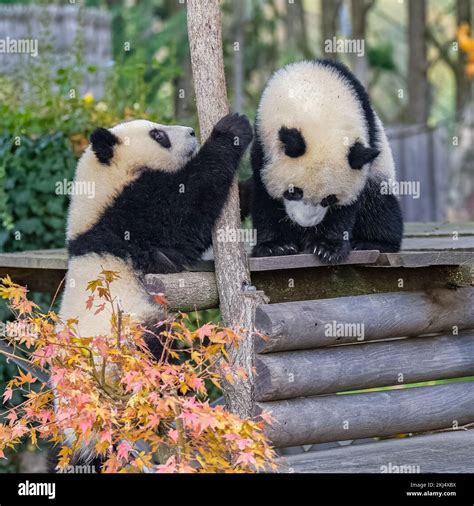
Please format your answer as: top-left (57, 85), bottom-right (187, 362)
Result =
top-left (60, 114), bottom-right (252, 354)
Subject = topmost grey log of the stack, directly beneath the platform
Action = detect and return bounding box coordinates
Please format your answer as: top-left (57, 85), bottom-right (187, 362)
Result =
top-left (255, 288), bottom-right (474, 353)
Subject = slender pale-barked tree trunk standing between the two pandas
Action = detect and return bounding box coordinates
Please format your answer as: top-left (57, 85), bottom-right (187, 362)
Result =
top-left (187, 0), bottom-right (263, 417)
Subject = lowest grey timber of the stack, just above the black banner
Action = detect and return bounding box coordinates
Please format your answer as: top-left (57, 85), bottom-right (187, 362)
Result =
top-left (278, 430), bottom-right (474, 473)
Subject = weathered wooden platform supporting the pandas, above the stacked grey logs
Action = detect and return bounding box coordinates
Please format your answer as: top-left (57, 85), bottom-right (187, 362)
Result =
top-left (0, 223), bottom-right (474, 311)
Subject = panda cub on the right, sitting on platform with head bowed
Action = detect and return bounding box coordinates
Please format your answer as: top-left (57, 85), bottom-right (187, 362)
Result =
top-left (251, 60), bottom-right (403, 263)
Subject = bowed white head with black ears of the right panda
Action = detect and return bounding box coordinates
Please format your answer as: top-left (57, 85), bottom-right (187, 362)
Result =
top-left (257, 62), bottom-right (378, 227)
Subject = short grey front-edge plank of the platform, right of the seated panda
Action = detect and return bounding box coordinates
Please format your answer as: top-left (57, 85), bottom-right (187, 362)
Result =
top-left (375, 250), bottom-right (474, 268)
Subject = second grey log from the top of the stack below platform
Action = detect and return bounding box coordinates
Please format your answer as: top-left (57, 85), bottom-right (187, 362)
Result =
top-left (255, 331), bottom-right (474, 401)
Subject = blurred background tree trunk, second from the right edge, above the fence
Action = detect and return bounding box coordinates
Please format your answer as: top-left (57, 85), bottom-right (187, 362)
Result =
top-left (407, 0), bottom-right (429, 124)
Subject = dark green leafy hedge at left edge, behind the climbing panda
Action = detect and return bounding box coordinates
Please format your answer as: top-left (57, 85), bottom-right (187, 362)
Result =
top-left (0, 132), bottom-right (76, 251)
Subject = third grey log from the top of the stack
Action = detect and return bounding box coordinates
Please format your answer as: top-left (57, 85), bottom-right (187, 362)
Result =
top-left (255, 382), bottom-right (474, 448)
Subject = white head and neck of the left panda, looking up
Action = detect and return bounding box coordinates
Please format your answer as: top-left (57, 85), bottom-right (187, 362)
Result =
top-left (67, 120), bottom-right (199, 239)
